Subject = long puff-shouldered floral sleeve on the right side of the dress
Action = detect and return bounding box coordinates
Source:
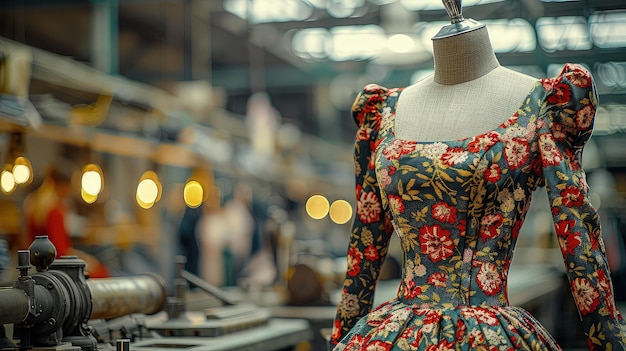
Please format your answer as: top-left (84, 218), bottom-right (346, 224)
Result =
top-left (539, 64), bottom-right (626, 350)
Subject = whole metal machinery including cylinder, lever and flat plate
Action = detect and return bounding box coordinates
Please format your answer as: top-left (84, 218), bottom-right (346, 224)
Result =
top-left (0, 236), bottom-right (311, 351)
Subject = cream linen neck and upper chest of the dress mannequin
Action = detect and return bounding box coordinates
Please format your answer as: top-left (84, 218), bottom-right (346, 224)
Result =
top-left (395, 27), bottom-right (537, 141)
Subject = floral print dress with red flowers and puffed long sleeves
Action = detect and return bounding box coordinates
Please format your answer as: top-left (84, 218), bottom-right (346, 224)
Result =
top-left (332, 64), bottom-right (626, 351)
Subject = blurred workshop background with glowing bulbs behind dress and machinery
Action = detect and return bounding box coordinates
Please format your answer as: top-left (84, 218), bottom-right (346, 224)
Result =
top-left (0, 0), bottom-right (626, 349)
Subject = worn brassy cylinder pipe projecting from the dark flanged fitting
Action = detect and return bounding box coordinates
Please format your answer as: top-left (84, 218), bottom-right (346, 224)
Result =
top-left (87, 274), bottom-right (168, 319)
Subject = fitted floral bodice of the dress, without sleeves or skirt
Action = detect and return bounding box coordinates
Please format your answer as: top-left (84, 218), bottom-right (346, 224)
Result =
top-left (374, 85), bottom-right (545, 306)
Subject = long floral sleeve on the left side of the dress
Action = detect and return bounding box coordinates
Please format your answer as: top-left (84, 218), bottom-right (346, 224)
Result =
top-left (331, 84), bottom-right (393, 345)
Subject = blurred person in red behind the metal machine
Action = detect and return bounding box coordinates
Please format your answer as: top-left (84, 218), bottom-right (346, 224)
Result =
top-left (23, 161), bottom-right (109, 278)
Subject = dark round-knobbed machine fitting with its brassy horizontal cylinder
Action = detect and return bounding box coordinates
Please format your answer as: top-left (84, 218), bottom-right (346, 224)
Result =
top-left (0, 236), bottom-right (168, 351)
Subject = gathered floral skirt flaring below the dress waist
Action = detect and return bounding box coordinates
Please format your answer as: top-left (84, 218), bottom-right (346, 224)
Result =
top-left (333, 298), bottom-right (561, 351)
